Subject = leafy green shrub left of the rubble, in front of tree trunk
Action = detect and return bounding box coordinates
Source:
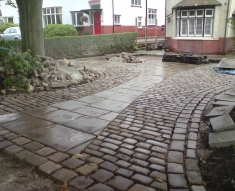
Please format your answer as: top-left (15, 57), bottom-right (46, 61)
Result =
top-left (0, 41), bottom-right (42, 90)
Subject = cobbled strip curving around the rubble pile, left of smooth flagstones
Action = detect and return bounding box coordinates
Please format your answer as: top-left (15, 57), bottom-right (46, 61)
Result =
top-left (0, 58), bottom-right (140, 115)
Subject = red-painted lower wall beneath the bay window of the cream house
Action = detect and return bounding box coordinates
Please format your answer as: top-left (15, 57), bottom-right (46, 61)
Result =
top-left (166, 37), bottom-right (235, 54)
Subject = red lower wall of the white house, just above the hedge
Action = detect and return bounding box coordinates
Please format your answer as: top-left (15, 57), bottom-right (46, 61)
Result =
top-left (77, 25), bottom-right (165, 37)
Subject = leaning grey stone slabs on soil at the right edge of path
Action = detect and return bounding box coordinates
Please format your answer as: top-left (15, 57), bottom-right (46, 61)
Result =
top-left (206, 89), bottom-right (235, 148)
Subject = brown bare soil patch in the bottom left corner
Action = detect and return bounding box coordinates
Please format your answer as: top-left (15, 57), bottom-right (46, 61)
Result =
top-left (0, 153), bottom-right (61, 191)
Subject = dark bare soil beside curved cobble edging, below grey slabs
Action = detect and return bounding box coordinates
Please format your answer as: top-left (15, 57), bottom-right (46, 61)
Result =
top-left (197, 104), bottom-right (235, 191)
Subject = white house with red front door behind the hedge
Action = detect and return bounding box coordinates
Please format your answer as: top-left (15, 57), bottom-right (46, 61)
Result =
top-left (0, 0), bottom-right (165, 36)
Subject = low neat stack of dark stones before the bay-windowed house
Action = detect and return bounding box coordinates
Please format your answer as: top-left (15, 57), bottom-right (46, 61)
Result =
top-left (162, 54), bottom-right (209, 64)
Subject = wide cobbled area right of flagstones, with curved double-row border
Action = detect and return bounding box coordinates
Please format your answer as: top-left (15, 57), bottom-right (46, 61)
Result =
top-left (81, 65), bottom-right (235, 190)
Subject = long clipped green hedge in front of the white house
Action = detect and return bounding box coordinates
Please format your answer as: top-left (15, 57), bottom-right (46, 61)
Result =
top-left (7, 33), bottom-right (137, 58)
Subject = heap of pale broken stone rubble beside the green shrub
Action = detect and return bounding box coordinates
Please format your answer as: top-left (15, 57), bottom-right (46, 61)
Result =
top-left (0, 58), bottom-right (100, 94)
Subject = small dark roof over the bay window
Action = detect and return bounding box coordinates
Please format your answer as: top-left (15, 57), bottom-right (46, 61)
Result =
top-left (173, 0), bottom-right (222, 9)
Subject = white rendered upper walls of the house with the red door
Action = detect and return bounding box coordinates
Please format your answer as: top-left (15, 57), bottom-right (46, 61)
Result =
top-left (0, 0), bottom-right (165, 26)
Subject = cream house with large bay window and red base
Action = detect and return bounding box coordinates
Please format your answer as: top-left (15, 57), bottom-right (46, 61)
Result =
top-left (166, 0), bottom-right (235, 54)
